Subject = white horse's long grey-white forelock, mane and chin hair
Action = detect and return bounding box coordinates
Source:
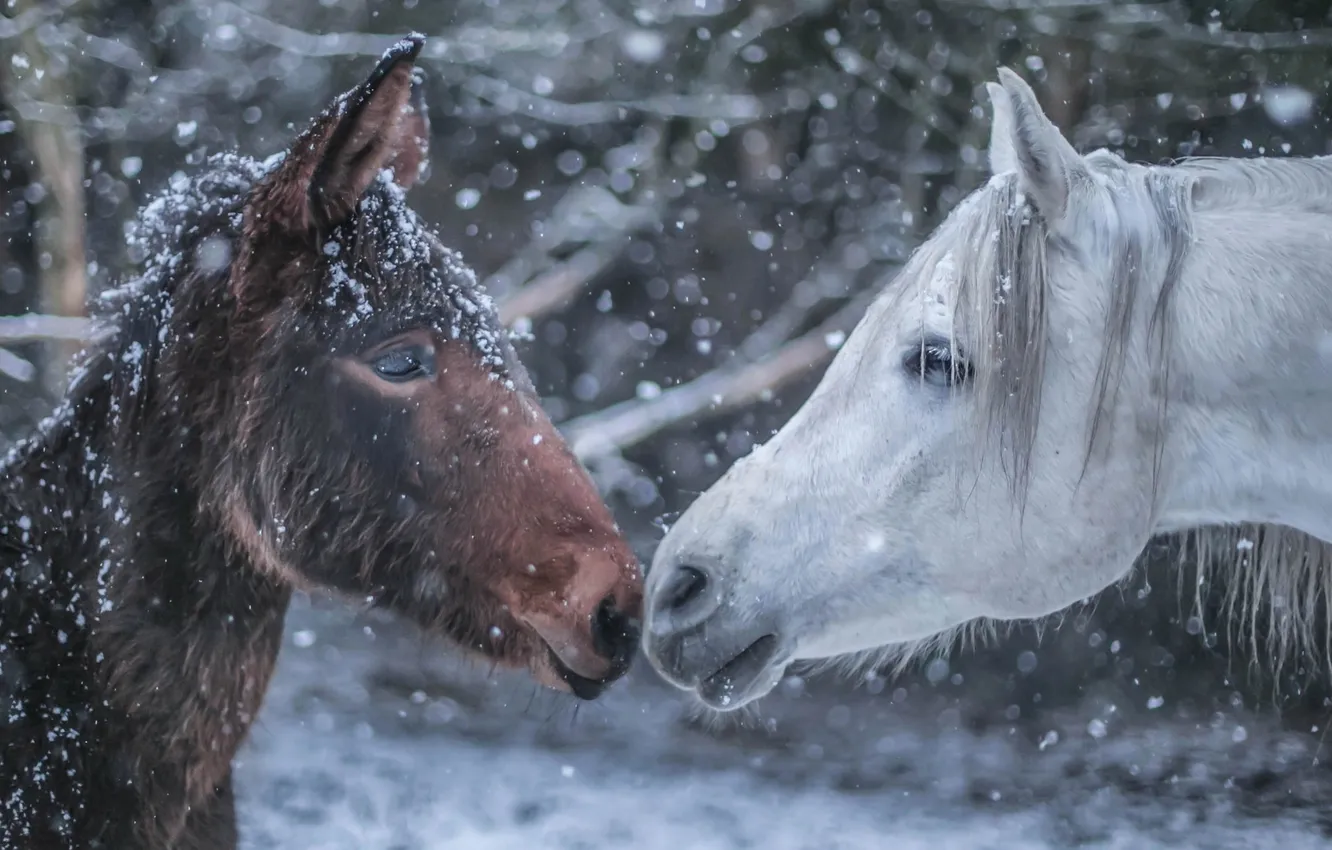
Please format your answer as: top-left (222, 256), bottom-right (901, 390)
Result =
top-left (813, 151), bottom-right (1332, 677)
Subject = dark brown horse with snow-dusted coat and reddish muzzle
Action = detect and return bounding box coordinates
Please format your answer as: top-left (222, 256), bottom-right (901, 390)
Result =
top-left (0, 36), bottom-right (641, 850)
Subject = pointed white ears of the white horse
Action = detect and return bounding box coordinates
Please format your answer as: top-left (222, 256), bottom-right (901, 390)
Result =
top-left (990, 68), bottom-right (1088, 222)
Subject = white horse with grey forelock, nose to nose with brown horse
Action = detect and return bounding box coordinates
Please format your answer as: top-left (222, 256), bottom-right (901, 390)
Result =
top-left (645, 69), bottom-right (1332, 710)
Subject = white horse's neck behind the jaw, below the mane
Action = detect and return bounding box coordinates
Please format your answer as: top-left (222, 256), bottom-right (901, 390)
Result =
top-left (1155, 204), bottom-right (1332, 541)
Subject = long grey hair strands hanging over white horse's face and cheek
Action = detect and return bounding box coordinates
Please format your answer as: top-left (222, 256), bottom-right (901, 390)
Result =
top-left (916, 159), bottom-right (1193, 502)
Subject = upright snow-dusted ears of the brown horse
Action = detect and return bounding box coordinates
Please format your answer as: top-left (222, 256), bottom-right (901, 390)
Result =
top-left (253, 33), bottom-right (430, 233)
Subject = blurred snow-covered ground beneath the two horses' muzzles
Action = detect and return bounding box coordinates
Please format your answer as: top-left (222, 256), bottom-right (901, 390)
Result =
top-left (237, 591), bottom-right (1332, 850)
